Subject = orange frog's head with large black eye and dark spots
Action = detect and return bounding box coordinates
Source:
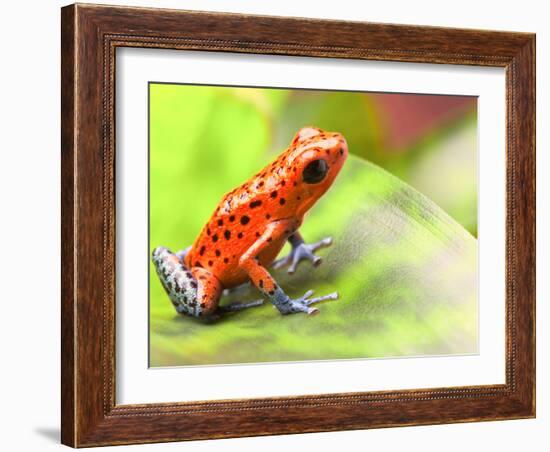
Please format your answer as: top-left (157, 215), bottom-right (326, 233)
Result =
top-left (287, 127), bottom-right (348, 213)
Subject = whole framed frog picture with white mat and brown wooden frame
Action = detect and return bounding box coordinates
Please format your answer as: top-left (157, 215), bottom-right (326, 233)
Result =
top-left (61, 4), bottom-right (535, 447)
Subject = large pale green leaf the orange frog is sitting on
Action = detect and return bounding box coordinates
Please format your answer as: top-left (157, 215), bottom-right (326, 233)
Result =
top-left (150, 156), bottom-right (478, 366)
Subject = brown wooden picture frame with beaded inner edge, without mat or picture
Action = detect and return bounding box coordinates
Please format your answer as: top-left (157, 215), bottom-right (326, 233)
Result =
top-left (61, 4), bottom-right (535, 447)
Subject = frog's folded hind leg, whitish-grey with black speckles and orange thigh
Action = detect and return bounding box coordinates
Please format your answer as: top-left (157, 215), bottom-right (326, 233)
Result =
top-left (152, 247), bottom-right (222, 317)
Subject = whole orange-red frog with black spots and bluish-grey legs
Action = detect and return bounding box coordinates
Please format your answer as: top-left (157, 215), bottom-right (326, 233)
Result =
top-left (152, 127), bottom-right (348, 317)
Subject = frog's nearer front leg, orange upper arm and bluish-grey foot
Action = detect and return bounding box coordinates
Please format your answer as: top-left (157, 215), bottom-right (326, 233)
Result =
top-left (239, 220), bottom-right (338, 314)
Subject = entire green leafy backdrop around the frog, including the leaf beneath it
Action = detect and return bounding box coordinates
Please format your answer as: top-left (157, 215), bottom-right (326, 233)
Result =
top-left (149, 84), bottom-right (477, 366)
